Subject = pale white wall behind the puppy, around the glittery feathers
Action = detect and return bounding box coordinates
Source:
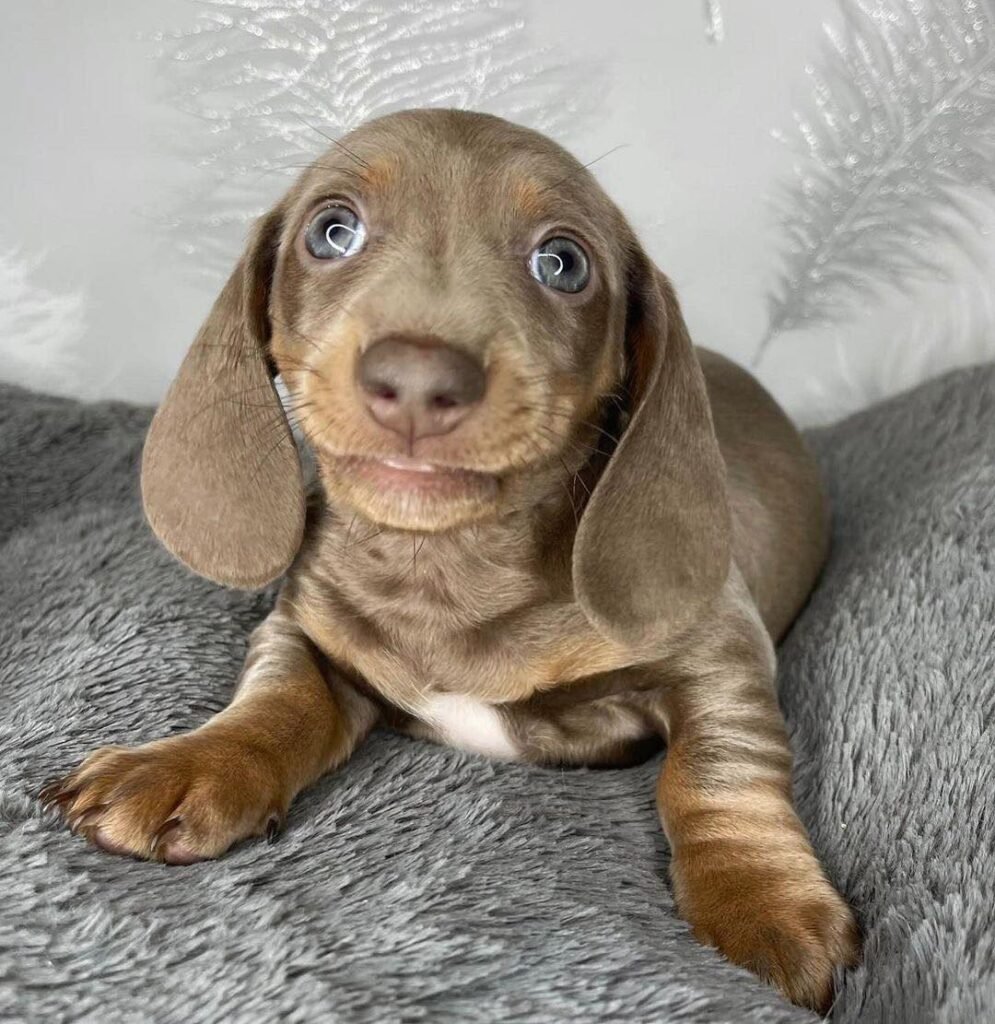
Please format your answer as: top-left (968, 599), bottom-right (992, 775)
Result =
top-left (0, 0), bottom-right (995, 422)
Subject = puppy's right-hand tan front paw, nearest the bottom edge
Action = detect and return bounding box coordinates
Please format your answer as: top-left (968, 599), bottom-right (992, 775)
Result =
top-left (670, 852), bottom-right (860, 1014)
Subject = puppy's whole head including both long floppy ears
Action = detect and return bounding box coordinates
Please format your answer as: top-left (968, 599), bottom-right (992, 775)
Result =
top-left (143, 111), bottom-right (729, 635)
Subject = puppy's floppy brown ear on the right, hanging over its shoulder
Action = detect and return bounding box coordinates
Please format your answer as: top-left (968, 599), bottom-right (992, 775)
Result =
top-left (573, 253), bottom-right (731, 643)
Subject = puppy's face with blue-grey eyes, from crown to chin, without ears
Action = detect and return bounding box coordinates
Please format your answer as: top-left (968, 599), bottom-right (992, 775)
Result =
top-left (269, 112), bottom-right (631, 530)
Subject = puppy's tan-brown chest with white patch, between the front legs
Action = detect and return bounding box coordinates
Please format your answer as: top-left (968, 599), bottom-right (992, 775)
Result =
top-left (298, 548), bottom-right (633, 759)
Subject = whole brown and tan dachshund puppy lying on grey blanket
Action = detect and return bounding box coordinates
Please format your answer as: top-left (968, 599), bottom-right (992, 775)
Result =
top-left (44, 110), bottom-right (858, 1009)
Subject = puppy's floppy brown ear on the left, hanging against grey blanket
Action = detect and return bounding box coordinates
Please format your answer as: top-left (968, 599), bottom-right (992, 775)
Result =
top-left (141, 210), bottom-right (304, 588)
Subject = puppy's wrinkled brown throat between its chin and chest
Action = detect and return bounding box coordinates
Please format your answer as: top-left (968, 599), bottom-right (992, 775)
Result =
top-left (296, 408), bottom-right (620, 637)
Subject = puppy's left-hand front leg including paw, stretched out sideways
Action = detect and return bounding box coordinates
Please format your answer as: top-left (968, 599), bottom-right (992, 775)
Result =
top-left (42, 605), bottom-right (377, 864)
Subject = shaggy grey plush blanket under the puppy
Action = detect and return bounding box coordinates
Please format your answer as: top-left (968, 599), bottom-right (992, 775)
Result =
top-left (0, 368), bottom-right (995, 1024)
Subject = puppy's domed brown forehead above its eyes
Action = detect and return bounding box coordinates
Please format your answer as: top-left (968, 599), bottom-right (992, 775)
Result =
top-left (296, 110), bottom-right (618, 233)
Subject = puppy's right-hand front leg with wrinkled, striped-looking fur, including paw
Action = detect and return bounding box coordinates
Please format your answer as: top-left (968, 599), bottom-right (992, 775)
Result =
top-left (657, 623), bottom-right (859, 1011)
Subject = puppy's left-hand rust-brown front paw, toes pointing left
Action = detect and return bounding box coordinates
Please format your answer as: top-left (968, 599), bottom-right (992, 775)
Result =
top-left (39, 730), bottom-right (289, 864)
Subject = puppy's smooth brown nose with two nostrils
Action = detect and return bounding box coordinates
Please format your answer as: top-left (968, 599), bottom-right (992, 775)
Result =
top-left (357, 335), bottom-right (486, 440)
